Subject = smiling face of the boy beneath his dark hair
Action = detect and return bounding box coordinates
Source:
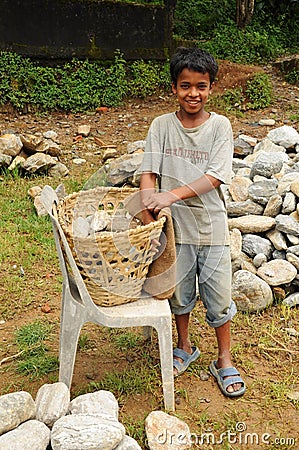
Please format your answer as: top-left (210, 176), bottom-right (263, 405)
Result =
top-left (172, 69), bottom-right (214, 115)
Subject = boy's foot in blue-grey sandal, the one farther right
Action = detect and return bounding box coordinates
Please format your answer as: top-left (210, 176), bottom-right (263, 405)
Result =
top-left (209, 361), bottom-right (246, 397)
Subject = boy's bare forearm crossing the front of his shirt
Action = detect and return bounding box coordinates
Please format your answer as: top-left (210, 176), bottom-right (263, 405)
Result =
top-left (142, 175), bottom-right (222, 213)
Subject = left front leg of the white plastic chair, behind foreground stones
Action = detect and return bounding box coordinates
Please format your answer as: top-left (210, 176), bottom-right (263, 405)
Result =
top-left (59, 287), bottom-right (84, 389)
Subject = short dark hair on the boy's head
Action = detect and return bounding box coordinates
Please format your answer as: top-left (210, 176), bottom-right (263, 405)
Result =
top-left (170, 47), bottom-right (218, 85)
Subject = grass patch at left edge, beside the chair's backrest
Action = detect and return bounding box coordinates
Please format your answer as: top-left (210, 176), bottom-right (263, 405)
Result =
top-left (0, 174), bottom-right (61, 319)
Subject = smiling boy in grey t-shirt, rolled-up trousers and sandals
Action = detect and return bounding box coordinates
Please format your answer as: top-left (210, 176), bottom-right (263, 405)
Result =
top-left (140, 48), bottom-right (245, 397)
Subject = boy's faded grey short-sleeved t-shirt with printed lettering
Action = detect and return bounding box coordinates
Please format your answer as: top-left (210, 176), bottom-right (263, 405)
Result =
top-left (140, 112), bottom-right (233, 245)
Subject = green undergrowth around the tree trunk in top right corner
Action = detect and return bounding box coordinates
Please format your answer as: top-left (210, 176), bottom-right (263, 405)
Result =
top-left (174, 0), bottom-right (299, 64)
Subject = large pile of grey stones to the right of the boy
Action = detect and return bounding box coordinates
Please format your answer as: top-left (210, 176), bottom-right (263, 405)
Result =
top-left (225, 125), bottom-right (299, 311)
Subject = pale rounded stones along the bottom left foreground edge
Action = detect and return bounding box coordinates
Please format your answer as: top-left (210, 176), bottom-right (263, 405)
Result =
top-left (0, 382), bottom-right (191, 450)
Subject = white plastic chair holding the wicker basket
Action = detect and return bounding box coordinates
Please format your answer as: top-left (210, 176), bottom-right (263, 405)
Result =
top-left (41, 186), bottom-right (175, 411)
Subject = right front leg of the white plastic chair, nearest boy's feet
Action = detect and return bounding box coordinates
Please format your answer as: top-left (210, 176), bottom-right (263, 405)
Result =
top-left (155, 318), bottom-right (175, 411)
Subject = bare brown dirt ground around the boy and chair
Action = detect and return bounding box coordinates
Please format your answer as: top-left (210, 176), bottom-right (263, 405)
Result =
top-left (0, 61), bottom-right (299, 449)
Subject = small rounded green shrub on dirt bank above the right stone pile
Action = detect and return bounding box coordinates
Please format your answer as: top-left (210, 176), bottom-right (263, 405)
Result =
top-left (245, 73), bottom-right (273, 109)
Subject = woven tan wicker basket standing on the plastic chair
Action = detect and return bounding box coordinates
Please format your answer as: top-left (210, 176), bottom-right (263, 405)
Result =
top-left (57, 187), bottom-right (166, 306)
